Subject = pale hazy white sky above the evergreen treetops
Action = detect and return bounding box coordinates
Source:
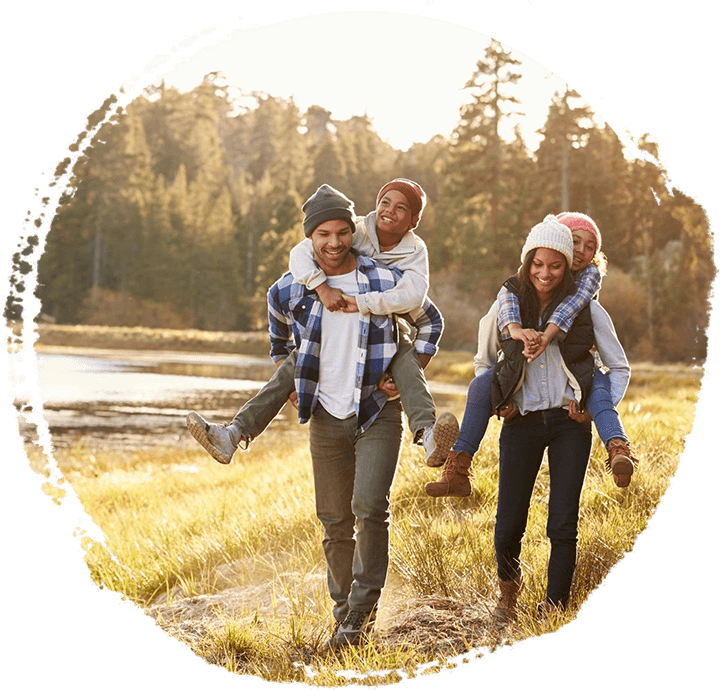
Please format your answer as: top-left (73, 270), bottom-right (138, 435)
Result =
top-left (146, 11), bottom-right (564, 150)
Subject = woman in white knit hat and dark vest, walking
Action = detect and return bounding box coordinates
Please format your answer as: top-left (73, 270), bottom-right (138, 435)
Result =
top-left (464, 216), bottom-right (630, 623)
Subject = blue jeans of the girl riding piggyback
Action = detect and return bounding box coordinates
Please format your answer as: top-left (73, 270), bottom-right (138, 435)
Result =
top-left (453, 367), bottom-right (628, 457)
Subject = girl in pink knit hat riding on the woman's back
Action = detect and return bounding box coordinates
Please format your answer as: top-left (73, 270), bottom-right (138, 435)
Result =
top-left (425, 213), bottom-right (637, 497)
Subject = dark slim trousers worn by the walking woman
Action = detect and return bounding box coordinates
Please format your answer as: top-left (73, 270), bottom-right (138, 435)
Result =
top-left (495, 409), bottom-right (592, 606)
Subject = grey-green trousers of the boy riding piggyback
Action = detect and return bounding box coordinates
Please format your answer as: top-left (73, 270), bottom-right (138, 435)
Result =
top-left (230, 333), bottom-right (435, 438)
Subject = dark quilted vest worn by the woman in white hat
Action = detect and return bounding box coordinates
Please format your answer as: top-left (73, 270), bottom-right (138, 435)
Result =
top-left (491, 276), bottom-right (595, 413)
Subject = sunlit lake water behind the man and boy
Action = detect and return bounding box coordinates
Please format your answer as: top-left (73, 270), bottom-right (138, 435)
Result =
top-left (14, 348), bottom-right (465, 450)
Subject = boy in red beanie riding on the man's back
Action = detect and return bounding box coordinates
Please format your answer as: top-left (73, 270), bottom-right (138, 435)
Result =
top-left (187, 178), bottom-right (459, 467)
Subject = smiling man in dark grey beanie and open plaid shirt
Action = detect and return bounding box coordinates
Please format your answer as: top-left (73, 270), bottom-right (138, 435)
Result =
top-left (268, 185), bottom-right (442, 647)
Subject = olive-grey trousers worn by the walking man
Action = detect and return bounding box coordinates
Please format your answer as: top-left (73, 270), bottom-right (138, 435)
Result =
top-left (310, 400), bottom-right (403, 621)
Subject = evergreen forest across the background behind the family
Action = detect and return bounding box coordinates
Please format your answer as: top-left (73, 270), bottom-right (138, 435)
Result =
top-left (31, 41), bottom-right (716, 362)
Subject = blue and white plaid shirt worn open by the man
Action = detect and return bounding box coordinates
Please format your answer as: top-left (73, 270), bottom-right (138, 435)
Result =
top-left (268, 255), bottom-right (443, 431)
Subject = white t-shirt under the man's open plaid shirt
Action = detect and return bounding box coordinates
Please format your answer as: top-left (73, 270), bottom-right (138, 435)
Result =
top-left (318, 270), bottom-right (360, 419)
